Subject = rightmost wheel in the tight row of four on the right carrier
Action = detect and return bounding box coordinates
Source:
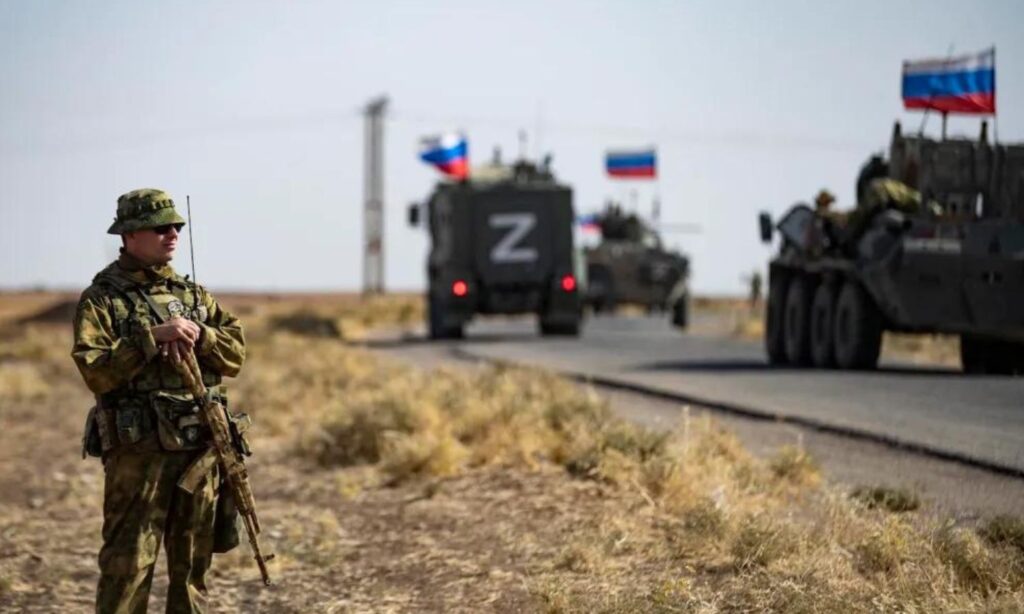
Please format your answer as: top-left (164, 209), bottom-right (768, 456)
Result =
top-left (833, 281), bottom-right (882, 368)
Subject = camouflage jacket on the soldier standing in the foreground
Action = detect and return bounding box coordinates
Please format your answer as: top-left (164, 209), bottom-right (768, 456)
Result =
top-left (72, 254), bottom-right (246, 397)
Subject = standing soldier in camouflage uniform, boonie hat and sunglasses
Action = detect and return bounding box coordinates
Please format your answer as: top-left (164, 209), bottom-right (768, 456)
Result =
top-left (72, 189), bottom-right (245, 613)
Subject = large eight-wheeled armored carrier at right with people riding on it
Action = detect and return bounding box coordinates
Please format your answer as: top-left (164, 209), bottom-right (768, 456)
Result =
top-left (760, 118), bottom-right (1024, 374)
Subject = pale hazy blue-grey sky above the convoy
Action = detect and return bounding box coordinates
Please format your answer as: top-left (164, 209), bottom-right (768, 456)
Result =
top-left (0, 0), bottom-right (1024, 293)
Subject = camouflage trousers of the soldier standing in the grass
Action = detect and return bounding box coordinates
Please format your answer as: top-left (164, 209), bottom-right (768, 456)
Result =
top-left (96, 441), bottom-right (218, 614)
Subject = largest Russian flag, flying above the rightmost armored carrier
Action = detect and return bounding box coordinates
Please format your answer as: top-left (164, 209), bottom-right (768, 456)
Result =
top-left (903, 47), bottom-right (995, 115)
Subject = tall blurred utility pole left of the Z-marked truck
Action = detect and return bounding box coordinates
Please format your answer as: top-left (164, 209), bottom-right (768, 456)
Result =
top-left (362, 96), bottom-right (388, 295)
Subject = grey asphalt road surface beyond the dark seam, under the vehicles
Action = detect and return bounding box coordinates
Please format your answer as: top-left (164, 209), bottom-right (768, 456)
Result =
top-left (452, 317), bottom-right (1024, 473)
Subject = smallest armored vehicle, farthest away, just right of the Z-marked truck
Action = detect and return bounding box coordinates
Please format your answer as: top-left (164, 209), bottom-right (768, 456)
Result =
top-left (584, 205), bottom-right (689, 326)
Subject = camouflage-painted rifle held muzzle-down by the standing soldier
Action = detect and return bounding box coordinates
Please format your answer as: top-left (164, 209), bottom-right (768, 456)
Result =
top-left (174, 351), bottom-right (273, 586)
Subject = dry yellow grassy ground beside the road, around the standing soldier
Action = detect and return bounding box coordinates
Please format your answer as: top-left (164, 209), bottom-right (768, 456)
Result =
top-left (0, 294), bottom-right (1024, 613)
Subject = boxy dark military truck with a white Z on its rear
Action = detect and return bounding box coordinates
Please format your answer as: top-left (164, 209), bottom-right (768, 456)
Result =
top-left (409, 161), bottom-right (583, 339)
